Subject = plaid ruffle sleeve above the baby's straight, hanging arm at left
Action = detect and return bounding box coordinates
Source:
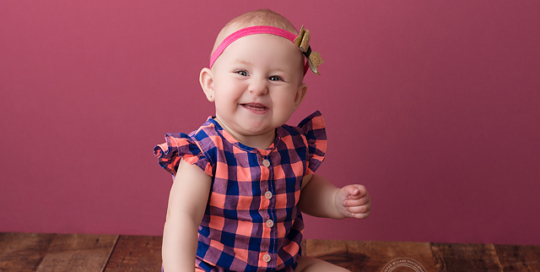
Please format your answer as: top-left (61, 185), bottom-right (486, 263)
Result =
top-left (154, 133), bottom-right (212, 176)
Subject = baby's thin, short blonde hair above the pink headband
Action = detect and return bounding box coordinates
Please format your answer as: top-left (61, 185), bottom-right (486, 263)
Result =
top-left (212, 9), bottom-right (298, 52)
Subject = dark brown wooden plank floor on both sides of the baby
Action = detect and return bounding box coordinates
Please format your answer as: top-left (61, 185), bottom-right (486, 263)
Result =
top-left (0, 233), bottom-right (540, 272)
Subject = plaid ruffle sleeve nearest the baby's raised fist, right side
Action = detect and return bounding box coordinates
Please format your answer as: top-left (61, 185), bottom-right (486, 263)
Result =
top-left (298, 111), bottom-right (326, 175)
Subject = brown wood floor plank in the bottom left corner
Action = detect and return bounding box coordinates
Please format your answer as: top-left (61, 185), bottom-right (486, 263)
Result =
top-left (0, 233), bottom-right (56, 272)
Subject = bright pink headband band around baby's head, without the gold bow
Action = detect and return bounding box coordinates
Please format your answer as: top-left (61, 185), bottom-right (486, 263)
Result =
top-left (210, 25), bottom-right (309, 74)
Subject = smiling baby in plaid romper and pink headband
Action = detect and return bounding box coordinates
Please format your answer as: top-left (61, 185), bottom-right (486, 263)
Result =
top-left (154, 10), bottom-right (371, 272)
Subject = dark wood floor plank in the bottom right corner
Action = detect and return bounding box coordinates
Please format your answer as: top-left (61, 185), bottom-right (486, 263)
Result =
top-left (495, 245), bottom-right (540, 272)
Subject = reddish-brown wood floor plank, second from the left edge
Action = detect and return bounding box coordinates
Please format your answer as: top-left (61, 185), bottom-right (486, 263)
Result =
top-left (37, 234), bottom-right (118, 272)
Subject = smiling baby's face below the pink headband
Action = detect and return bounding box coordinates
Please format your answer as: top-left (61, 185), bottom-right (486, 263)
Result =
top-left (212, 34), bottom-right (307, 139)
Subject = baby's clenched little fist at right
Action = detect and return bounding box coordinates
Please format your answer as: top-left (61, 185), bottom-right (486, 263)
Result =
top-left (335, 184), bottom-right (371, 219)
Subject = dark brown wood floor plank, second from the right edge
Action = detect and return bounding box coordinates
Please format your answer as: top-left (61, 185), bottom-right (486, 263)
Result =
top-left (431, 243), bottom-right (503, 272)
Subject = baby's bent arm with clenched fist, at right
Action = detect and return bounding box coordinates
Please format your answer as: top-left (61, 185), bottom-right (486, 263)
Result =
top-left (298, 174), bottom-right (371, 219)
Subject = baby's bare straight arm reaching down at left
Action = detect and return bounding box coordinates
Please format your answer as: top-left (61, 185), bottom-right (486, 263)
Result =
top-left (162, 160), bottom-right (212, 272)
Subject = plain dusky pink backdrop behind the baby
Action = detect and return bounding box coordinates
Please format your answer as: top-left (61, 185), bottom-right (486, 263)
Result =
top-left (0, 0), bottom-right (540, 244)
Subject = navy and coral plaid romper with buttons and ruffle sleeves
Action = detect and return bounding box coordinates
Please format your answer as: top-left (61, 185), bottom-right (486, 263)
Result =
top-left (154, 111), bottom-right (326, 271)
